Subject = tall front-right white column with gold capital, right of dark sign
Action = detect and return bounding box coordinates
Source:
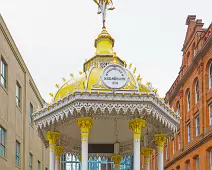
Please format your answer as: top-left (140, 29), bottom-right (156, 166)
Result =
top-left (129, 118), bottom-right (146, 170)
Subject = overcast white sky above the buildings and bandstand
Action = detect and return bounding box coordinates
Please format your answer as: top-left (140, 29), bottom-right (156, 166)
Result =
top-left (0, 0), bottom-right (212, 102)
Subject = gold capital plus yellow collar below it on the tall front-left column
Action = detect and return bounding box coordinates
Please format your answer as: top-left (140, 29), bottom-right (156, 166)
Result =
top-left (78, 117), bottom-right (93, 141)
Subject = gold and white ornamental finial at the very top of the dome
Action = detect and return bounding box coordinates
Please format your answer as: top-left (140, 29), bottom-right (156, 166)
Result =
top-left (93, 0), bottom-right (115, 28)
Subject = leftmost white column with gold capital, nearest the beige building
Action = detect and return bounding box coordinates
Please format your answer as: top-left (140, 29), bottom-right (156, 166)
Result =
top-left (46, 132), bottom-right (60, 170)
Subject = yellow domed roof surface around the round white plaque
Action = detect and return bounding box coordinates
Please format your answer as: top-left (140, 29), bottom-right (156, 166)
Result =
top-left (54, 64), bottom-right (151, 101)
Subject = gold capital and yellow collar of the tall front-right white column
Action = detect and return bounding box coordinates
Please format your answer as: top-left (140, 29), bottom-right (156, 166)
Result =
top-left (129, 118), bottom-right (146, 140)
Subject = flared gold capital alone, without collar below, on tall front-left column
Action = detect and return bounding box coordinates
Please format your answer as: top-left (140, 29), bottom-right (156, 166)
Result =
top-left (78, 117), bottom-right (93, 133)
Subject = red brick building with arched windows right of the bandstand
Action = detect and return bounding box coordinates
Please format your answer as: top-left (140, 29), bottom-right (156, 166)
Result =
top-left (152, 15), bottom-right (212, 170)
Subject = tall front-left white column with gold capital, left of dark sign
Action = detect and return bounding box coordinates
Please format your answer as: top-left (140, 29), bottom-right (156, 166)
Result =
top-left (78, 118), bottom-right (93, 170)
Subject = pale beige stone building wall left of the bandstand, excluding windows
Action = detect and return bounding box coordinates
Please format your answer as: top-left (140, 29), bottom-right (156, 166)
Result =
top-left (0, 16), bottom-right (49, 170)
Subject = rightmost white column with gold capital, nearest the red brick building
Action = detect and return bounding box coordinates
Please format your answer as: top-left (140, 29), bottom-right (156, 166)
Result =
top-left (155, 134), bottom-right (166, 170)
